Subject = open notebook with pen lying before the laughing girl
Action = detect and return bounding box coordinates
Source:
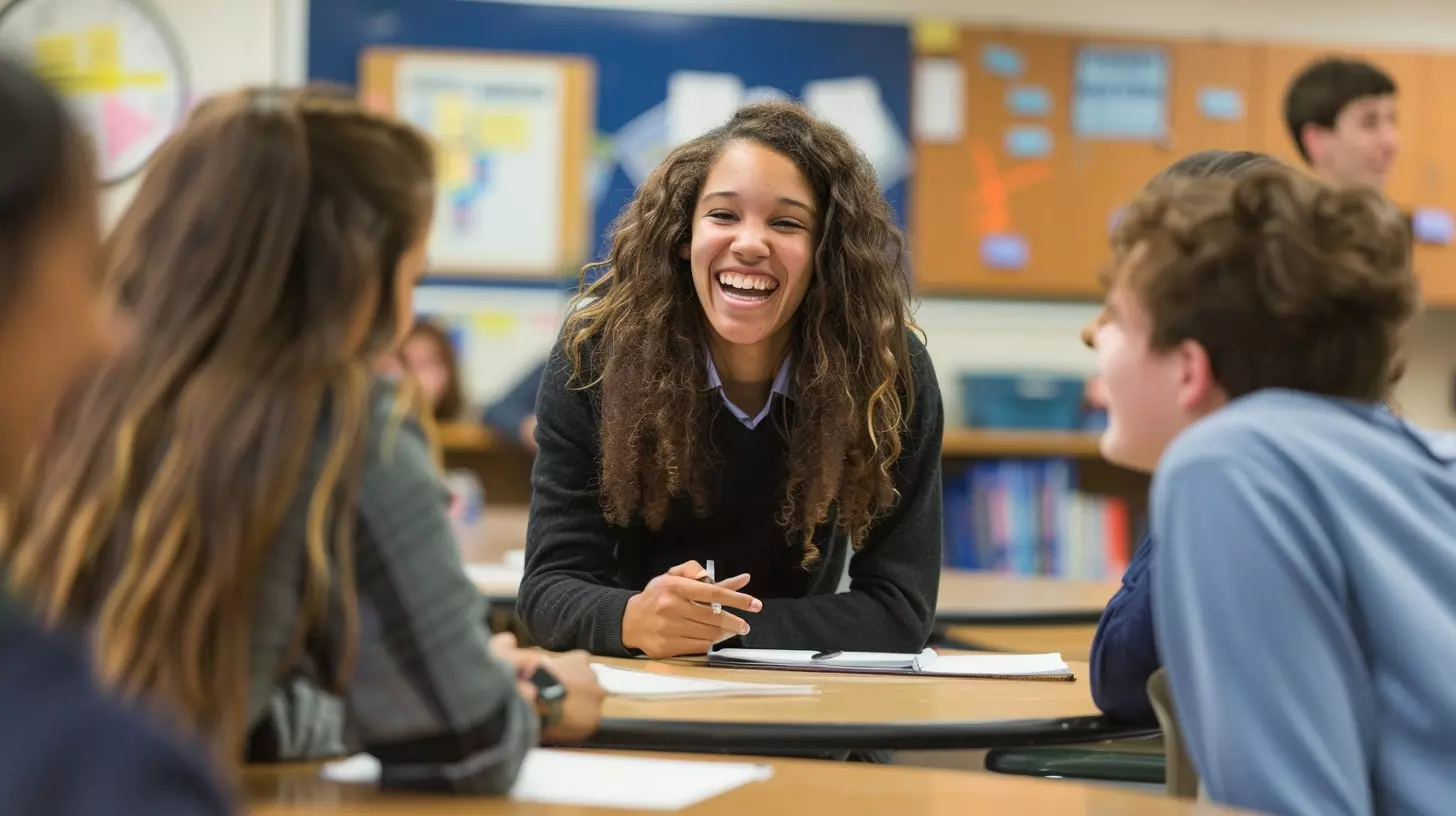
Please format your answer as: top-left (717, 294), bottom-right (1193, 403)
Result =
top-left (708, 648), bottom-right (1076, 680)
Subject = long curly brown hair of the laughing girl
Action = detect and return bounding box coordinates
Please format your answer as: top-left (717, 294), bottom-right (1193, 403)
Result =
top-left (562, 102), bottom-right (914, 565)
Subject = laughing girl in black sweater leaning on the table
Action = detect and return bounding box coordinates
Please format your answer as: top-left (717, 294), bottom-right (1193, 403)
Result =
top-left (518, 103), bottom-right (942, 657)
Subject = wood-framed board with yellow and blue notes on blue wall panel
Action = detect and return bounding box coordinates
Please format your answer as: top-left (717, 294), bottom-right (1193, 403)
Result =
top-left (360, 48), bottom-right (596, 278)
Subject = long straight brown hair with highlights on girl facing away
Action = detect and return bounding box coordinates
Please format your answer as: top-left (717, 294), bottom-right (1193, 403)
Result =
top-left (0, 90), bottom-right (434, 756)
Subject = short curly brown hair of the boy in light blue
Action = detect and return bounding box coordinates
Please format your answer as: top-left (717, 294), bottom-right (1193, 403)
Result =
top-left (1107, 168), bottom-right (1418, 401)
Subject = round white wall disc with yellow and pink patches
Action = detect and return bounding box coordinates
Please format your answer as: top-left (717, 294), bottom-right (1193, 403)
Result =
top-left (0, 0), bottom-right (191, 185)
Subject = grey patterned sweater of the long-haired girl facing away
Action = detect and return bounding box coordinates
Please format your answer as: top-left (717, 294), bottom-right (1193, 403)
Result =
top-left (249, 386), bottom-right (537, 794)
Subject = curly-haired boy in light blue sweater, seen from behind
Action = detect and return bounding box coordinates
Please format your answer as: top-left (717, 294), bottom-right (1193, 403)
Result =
top-left (1096, 169), bottom-right (1456, 816)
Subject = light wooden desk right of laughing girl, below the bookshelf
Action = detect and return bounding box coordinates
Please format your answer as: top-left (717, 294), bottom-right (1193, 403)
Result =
top-left (935, 570), bottom-right (1120, 627)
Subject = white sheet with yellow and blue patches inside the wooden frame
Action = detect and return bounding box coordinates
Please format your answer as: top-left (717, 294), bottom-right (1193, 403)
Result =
top-left (395, 55), bottom-right (566, 275)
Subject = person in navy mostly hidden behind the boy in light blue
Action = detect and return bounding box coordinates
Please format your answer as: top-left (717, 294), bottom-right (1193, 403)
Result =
top-left (1082, 150), bottom-right (1278, 723)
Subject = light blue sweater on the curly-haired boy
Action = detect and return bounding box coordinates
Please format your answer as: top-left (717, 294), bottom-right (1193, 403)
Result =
top-left (1152, 391), bottom-right (1456, 816)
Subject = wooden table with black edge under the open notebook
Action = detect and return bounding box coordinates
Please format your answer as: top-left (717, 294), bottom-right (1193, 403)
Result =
top-left (593, 659), bottom-right (1158, 753)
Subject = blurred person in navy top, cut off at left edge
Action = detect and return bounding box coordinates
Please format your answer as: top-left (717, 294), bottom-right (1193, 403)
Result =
top-left (0, 57), bottom-right (229, 816)
